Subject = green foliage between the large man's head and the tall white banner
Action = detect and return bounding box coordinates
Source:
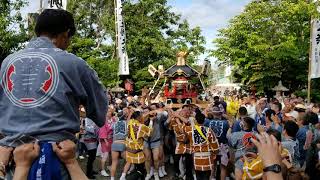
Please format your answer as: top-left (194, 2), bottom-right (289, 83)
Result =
top-left (68, 0), bottom-right (120, 87)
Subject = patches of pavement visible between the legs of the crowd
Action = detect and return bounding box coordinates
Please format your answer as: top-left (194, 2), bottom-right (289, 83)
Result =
top-left (79, 157), bottom-right (174, 180)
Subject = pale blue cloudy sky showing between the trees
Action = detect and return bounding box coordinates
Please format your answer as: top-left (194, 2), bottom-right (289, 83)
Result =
top-left (22, 0), bottom-right (251, 62)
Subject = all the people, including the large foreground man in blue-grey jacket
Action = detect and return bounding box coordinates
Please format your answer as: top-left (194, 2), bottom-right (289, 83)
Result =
top-left (0, 9), bottom-right (320, 180)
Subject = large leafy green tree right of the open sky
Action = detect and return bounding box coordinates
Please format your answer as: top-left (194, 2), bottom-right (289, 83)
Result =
top-left (212, 0), bottom-right (316, 92)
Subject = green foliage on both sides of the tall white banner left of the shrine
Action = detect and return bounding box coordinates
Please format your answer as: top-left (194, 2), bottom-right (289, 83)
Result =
top-left (68, 0), bottom-right (205, 89)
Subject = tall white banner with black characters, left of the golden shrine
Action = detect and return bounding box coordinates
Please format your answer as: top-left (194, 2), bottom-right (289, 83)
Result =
top-left (115, 0), bottom-right (130, 75)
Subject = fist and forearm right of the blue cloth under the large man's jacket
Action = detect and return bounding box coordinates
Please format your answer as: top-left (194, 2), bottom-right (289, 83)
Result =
top-left (52, 140), bottom-right (88, 180)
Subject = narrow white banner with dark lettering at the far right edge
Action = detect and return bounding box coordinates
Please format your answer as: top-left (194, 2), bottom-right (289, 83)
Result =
top-left (310, 20), bottom-right (320, 79)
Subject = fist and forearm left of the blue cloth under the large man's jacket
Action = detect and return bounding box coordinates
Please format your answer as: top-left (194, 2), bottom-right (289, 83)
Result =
top-left (13, 143), bottom-right (40, 180)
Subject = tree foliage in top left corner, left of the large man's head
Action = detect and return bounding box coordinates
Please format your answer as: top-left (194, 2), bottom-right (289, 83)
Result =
top-left (0, 0), bottom-right (28, 64)
